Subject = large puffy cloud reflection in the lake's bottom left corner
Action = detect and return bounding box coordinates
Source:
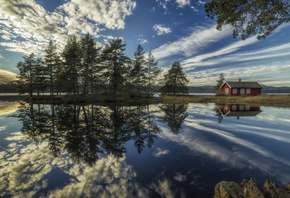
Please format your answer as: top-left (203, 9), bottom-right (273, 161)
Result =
top-left (0, 132), bottom-right (149, 197)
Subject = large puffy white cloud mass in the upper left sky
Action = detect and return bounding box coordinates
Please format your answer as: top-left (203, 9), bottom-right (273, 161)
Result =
top-left (0, 0), bottom-right (136, 54)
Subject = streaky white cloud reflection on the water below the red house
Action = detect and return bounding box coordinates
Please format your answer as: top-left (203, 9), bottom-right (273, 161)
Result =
top-left (160, 104), bottom-right (290, 184)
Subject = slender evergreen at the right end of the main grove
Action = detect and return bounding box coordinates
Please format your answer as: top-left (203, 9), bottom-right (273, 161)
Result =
top-left (146, 52), bottom-right (161, 97)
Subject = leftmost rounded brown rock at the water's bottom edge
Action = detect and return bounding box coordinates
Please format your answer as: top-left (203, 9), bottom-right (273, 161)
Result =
top-left (214, 181), bottom-right (242, 198)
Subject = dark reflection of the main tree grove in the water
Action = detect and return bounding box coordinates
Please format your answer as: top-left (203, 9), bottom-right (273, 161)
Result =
top-left (13, 103), bottom-right (161, 166)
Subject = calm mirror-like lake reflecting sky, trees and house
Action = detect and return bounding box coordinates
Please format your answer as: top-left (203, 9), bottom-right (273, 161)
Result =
top-left (0, 102), bottom-right (290, 198)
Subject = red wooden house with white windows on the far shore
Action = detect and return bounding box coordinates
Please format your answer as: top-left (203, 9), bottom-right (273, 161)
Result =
top-left (220, 79), bottom-right (263, 96)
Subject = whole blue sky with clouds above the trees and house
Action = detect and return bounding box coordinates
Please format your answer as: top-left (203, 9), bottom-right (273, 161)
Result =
top-left (0, 0), bottom-right (290, 86)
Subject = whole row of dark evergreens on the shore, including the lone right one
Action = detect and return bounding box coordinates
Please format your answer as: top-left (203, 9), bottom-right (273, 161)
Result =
top-left (17, 34), bottom-right (188, 100)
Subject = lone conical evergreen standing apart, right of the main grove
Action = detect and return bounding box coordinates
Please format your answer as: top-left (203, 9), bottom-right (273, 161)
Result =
top-left (160, 61), bottom-right (189, 95)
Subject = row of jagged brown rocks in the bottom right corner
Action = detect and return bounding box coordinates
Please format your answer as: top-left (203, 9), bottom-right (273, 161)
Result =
top-left (214, 178), bottom-right (290, 198)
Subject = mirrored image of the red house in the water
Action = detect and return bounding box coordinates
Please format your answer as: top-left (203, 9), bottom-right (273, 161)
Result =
top-left (220, 104), bottom-right (262, 119)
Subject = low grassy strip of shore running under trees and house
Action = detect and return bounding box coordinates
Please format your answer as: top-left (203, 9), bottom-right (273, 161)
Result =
top-left (0, 94), bottom-right (290, 107)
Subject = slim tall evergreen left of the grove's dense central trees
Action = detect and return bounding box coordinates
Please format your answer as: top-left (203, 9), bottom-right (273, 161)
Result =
top-left (44, 40), bottom-right (61, 95)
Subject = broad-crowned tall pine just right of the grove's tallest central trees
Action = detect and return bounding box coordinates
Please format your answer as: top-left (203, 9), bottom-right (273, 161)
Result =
top-left (102, 39), bottom-right (129, 94)
